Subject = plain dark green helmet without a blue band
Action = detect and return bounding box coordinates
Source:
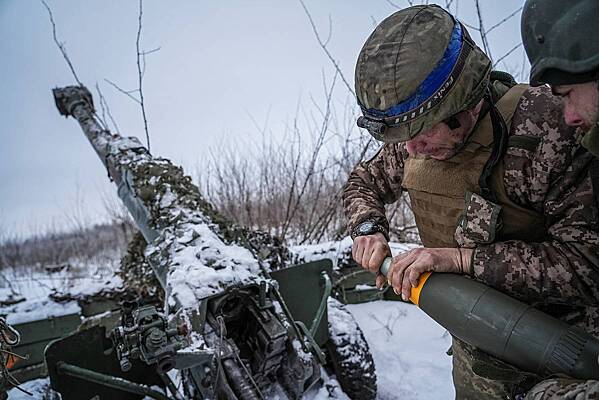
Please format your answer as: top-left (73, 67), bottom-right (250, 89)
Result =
top-left (521, 0), bottom-right (599, 85)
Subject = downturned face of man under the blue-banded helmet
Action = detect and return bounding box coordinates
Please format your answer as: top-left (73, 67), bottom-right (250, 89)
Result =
top-left (406, 101), bottom-right (482, 160)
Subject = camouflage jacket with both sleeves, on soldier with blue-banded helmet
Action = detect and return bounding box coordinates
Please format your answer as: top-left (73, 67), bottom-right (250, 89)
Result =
top-left (343, 87), bottom-right (599, 336)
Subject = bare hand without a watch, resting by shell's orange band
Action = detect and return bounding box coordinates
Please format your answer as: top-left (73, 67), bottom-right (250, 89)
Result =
top-left (387, 247), bottom-right (474, 301)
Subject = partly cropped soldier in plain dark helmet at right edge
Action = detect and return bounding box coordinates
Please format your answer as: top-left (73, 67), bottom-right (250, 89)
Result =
top-left (522, 0), bottom-right (599, 400)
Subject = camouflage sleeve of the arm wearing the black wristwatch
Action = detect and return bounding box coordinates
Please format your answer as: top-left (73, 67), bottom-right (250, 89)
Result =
top-left (343, 143), bottom-right (403, 236)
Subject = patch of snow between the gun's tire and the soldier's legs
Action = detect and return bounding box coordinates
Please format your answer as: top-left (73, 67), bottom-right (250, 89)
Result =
top-left (348, 301), bottom-right (454, 400)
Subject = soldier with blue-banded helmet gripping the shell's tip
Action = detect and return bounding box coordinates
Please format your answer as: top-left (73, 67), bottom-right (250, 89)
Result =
top-left (343, 6), bottom-right (599, 399)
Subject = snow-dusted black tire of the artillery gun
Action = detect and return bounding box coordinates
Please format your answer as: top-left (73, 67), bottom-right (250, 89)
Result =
top-left (326, 297), bottom-right (376, 400)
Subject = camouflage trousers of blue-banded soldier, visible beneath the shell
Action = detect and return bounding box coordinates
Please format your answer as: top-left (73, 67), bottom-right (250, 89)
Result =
top-left (451, 337), bottom-right (541, 400)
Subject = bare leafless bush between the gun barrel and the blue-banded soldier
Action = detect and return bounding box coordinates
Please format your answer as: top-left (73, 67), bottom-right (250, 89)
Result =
top-left (197, 83), bottom-right (417, 244)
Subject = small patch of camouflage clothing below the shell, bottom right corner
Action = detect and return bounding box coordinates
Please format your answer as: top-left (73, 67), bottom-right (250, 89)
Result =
top-left (523, 378), bottom-right (599, 400)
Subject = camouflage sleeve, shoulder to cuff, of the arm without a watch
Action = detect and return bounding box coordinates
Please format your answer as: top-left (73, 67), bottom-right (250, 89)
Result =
top-left (472, 88), bottom-right (599, 306)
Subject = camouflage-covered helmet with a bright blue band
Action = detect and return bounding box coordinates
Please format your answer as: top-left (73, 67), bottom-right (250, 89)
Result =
top-left (355, 5), bottom-right (491, 142)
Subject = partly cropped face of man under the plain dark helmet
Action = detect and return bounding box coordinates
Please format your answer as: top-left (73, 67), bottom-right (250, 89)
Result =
top-left (551, 82), bottom-right (599, 129)
